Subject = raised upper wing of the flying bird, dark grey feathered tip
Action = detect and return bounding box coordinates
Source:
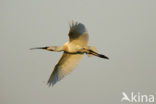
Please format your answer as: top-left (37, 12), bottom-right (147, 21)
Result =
top-left (68, 21), bottom-right (89, 43)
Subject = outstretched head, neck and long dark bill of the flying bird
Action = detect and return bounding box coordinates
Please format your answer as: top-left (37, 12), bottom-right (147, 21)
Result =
top-left (30, 46), bottom-right (63, 52)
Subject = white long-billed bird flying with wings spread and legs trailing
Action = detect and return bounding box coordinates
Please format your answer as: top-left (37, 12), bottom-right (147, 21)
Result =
top-left (31, 21), bottom-right (109, 86)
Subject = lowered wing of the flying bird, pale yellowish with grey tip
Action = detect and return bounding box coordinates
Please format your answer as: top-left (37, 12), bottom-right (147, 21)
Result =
top-left (47, 53), bottom-right (83, 86)
